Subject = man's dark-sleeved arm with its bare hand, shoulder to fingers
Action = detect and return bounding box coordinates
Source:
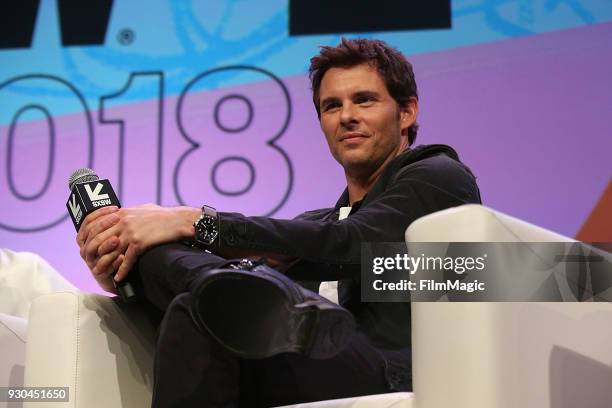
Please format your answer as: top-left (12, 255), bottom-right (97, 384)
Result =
top-left (79, 155), bottom-right (480, 280)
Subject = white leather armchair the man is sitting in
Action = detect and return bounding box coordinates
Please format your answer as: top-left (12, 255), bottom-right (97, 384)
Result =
top-left (24, 205), bottom-right (612, 408)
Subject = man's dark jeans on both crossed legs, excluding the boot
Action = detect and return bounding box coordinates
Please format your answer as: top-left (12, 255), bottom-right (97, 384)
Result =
top-left (135, 244), bottom-right (391, 408)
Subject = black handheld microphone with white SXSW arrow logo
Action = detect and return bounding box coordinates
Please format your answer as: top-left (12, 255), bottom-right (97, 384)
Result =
top-left (66, 168), bottom-right (136, 301)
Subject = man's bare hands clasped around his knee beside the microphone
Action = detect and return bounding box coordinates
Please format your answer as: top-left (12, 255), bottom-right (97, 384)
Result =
top-left (77, 204), bottom-right (201, 291)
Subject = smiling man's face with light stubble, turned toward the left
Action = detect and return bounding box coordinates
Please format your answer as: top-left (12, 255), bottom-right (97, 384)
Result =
top-left (319, 64), bottom-right (417, 177)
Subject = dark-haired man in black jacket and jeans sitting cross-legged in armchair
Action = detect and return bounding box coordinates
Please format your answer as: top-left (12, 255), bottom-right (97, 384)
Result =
top-left (77, 39), bottom-right (480, 407)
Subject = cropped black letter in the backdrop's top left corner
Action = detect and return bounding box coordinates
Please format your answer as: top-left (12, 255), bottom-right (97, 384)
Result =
top-left (0, 0), bottom-right (113, 49)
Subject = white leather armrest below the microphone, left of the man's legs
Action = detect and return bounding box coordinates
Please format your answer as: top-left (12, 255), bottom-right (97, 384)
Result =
top-left (24, 292), bottom-right (155, 408)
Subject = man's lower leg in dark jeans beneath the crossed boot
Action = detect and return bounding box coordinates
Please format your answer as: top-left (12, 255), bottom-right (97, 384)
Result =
top-left (152, 293), bottom-right (392, 408)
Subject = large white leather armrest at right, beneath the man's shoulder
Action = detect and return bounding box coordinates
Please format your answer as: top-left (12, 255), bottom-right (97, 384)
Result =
top-left (406, 205), bottom-right (612, 408)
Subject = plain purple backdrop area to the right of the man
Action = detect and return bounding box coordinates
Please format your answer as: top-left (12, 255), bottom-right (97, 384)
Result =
top-left (413, 24), bottom-right (612, 236)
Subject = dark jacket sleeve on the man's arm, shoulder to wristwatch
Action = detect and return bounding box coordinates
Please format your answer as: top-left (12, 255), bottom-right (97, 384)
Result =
top-left (219, 155), bottom-right (480, 272)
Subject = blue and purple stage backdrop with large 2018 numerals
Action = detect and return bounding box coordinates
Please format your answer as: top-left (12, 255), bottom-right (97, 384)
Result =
top-left (0, 0), bottom-right (612, 290)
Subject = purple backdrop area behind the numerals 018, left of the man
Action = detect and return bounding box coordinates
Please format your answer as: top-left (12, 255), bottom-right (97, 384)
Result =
top-left (0, 76), bottom-right (344, 291)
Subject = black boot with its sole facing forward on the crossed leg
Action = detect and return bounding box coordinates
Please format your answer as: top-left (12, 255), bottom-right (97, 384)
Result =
top-left (191, 260), bottom-right (355, 358)
